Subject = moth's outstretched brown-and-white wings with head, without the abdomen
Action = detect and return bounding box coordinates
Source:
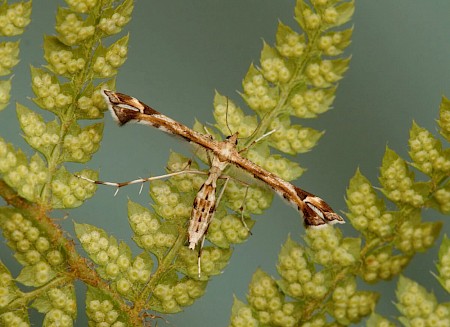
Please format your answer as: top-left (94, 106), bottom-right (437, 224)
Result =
top-left (102, 90), bottom-right (345, 227)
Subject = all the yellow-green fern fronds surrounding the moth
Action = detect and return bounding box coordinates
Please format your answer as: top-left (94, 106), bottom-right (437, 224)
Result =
top-left (0, 0), bottom-right (450, 327)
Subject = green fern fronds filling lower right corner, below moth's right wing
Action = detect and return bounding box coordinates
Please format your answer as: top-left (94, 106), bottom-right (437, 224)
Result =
top-left (230, 94), bottom-right (450, 327)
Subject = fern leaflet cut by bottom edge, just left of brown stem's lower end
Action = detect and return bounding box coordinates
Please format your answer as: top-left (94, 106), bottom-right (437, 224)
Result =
top-left (86, 299), bottom-right (126, 327)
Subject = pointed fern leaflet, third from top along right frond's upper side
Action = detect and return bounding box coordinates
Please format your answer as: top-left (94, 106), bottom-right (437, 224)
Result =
top-left (380, 149), bottom-right (425, 208)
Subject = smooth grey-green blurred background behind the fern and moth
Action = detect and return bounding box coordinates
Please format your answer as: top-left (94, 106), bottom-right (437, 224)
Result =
top-left (0, 0), bottom-right (450, 326)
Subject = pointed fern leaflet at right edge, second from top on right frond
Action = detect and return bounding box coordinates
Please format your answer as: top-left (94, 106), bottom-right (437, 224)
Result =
top-left (409, 123), bottom-right (450, 175)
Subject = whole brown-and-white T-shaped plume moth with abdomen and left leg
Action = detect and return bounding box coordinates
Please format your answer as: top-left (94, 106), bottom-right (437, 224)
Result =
top-left (79, 90), bottom-right (345, 274)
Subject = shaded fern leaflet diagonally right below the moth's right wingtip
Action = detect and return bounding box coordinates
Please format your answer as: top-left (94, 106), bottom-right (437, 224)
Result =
top-left (361, 246), bottom-right (411, 283)
